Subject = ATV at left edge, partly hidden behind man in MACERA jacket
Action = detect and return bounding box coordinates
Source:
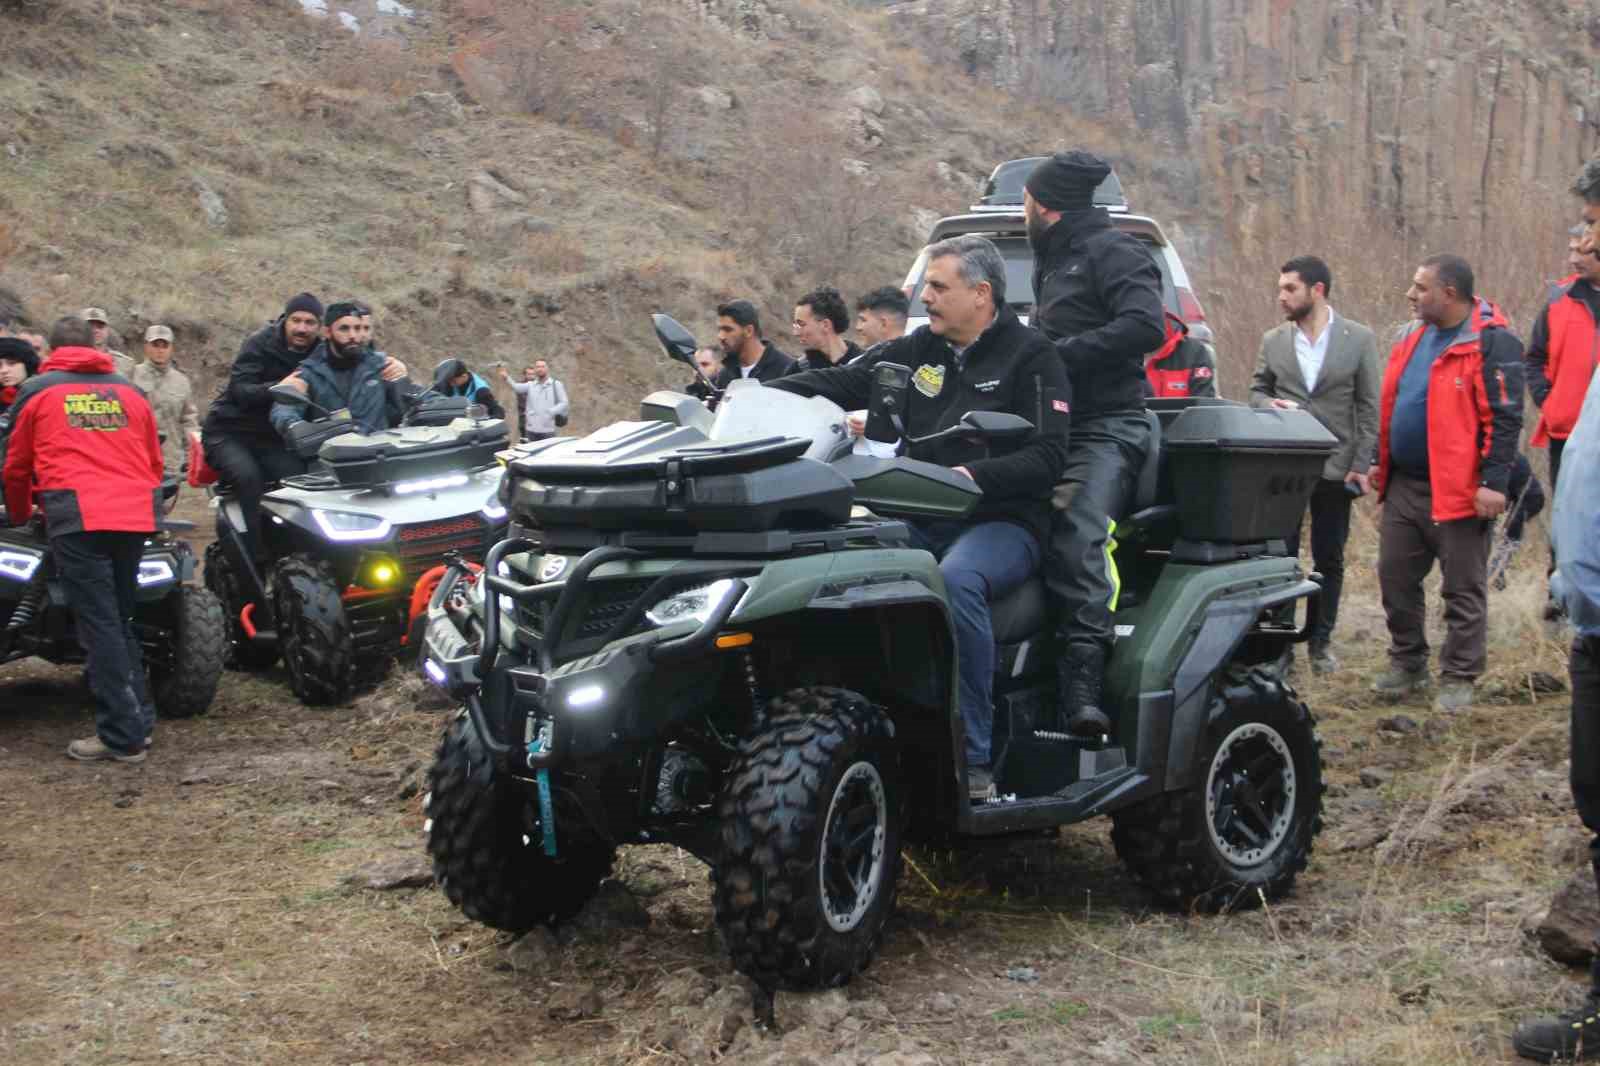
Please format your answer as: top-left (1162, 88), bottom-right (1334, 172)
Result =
top-left (0, 482), bottom-right (226, 719)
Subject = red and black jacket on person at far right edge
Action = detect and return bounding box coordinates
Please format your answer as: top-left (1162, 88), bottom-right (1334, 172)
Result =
top-left (1526, 275), bottom-right (1600, 448)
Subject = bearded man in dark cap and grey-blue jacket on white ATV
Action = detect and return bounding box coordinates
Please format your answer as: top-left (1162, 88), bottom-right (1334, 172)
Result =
top-left (272, 301), bottom-right (405, 435)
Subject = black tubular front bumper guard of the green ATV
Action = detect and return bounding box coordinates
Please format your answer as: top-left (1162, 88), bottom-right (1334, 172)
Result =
top-left (422, 538), bottom-right (749, 770)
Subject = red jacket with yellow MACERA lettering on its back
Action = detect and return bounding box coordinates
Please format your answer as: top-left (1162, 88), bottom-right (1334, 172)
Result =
top-left (0, 347), bottom-right (163, 536)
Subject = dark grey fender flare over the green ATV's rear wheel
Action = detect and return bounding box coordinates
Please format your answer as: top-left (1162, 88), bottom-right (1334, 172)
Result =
top-left (1162, 581), bottom-right (1320, 792)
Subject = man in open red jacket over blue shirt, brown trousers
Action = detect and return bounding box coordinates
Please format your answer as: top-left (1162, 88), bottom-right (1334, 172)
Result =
top-left (1373, 254), bottom-right (1522, 711)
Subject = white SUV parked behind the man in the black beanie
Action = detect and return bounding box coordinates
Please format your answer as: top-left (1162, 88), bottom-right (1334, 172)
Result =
top-left (901, 155), bottom-right (1221, 364)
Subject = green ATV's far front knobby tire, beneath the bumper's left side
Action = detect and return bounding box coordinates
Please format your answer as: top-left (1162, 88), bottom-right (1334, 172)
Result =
top-left (427, 714), bottom-right (616, 933)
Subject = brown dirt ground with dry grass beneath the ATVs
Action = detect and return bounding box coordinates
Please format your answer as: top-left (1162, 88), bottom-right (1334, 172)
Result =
top-left (0, 501), bottom-right (1584, 1066)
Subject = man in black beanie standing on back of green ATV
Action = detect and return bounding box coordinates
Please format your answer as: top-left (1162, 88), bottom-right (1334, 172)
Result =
top-left (1022, 152), bottom-right (1163, 736)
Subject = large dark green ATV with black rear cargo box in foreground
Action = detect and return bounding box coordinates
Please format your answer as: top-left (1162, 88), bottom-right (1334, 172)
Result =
top-left (421, 315), bottom-right (1333, 991)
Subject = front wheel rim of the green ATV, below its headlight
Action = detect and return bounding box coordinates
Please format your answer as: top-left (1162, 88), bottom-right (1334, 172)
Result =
top-left (818, 762), bottom-right (890, 933)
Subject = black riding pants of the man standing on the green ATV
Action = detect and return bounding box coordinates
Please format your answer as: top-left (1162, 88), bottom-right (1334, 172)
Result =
top-left (1045, 411), bottom-right (1150, 653)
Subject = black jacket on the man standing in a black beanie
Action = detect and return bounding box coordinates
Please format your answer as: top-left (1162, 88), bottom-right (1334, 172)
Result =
top-left (1032, 208), bottom-right (1165, 418)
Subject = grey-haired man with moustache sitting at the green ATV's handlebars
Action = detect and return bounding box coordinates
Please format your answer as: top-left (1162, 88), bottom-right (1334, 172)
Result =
top-left (766, 237), bottom-right (1069, 799)
